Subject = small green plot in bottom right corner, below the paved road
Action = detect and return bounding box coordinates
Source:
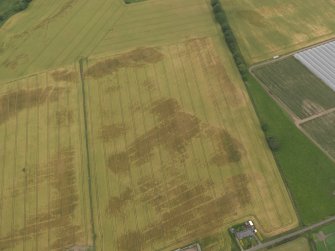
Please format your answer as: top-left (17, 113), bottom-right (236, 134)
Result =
top-left (312, 224), bottom-right (335, 251)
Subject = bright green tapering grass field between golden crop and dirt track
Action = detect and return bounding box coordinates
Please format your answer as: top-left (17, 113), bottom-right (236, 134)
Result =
top-left (247, 76), bottom-right (335, 225)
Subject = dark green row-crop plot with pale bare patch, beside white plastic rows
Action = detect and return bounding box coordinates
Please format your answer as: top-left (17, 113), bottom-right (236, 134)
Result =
top-left (253, 56), bottom-right (335, 118)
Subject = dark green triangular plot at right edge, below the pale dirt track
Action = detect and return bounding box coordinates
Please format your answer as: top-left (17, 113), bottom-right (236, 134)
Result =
top-left (301, 112), bottom-right (335, 159)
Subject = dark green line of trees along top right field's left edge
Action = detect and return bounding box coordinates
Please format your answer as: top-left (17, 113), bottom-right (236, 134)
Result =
top-left (211, 0), bottom-right (248, 81)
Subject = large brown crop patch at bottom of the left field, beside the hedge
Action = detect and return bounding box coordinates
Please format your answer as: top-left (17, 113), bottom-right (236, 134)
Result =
top-left (0, 149), bottom-right (82, 250)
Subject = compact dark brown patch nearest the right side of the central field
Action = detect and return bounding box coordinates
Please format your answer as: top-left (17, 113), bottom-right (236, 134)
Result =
top-left (207, 128), bottom-right (245, 166)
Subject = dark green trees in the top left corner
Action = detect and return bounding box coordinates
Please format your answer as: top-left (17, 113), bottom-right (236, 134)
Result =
top-left (0, 0), bottom-right (31, 26)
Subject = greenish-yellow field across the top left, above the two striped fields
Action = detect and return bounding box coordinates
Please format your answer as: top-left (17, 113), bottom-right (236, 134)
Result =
top-left (0, 0), bottom-right (216, 80)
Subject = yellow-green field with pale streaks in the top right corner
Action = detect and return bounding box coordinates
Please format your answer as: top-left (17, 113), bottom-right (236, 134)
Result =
top-left (221, 0), bottom-right (335, 64)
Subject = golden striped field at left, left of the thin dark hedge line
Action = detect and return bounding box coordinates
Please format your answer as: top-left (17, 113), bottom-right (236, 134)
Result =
top-left (0, 70), bottom-right (92, 251)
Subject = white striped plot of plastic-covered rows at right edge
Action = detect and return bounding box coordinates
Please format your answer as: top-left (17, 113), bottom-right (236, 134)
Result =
top-left (294, 41), bottom-right (335, 91)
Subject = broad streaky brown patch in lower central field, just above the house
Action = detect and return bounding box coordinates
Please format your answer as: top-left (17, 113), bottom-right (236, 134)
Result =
top-left (124, 175), bottom-right (250, 247)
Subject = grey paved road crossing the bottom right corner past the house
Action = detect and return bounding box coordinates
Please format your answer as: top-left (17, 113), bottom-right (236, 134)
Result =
top-left (245, 216), bottom-right (335, 251)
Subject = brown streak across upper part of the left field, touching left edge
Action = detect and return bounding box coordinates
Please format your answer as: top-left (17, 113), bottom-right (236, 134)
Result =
top-left (0, 87), bottom-right (66, 124)
